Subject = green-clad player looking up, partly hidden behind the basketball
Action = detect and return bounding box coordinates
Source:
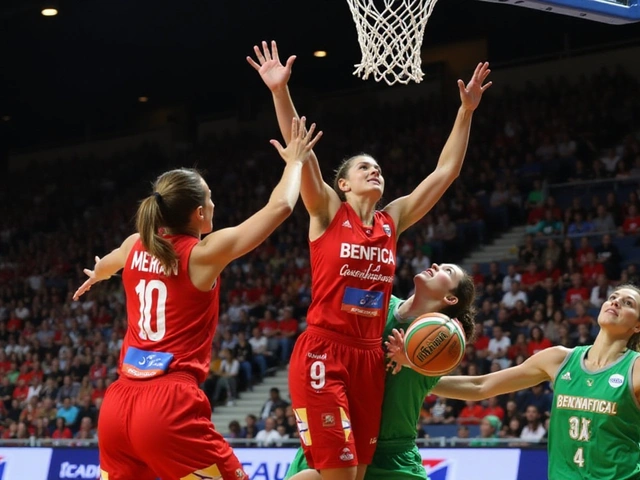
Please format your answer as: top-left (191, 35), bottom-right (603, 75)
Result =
top-left (285, 263), bottom-right (475, 480)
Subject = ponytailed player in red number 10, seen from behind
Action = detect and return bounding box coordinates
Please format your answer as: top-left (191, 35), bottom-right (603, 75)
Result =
top-left (74, 118), bottom-right (321, 480)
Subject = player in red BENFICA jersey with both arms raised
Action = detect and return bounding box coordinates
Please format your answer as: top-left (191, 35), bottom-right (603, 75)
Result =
top-left (247, 42), bottom-right (491, 480)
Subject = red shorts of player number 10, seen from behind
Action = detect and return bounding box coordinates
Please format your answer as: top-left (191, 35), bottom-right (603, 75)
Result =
top-left (98, 372), bottom-right (249, 480)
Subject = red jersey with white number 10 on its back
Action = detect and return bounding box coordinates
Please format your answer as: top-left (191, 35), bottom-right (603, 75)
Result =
top-left (119, 235), bottom-right (220, 383)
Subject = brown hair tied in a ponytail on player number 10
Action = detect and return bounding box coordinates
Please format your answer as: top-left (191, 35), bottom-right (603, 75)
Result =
top-left (136, 168), bottom-right (206, 275)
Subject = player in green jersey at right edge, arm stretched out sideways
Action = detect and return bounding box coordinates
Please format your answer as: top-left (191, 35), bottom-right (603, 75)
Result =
top-left (389, 285), bottom-right (640, 480)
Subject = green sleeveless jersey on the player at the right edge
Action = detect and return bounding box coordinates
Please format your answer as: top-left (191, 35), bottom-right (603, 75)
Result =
top-left (549, 346), bottom-right (640, 480)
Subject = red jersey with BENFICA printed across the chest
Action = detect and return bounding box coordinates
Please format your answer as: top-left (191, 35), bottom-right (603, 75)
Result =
top-left (307, 202), bottom-right (396, 339)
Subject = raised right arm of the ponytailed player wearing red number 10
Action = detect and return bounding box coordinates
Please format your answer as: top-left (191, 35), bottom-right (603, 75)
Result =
top-left (197, 117), bottom-right (322, 273)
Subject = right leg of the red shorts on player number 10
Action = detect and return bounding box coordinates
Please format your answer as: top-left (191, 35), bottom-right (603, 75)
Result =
top-left (130, 384), bottom-right (247, 480)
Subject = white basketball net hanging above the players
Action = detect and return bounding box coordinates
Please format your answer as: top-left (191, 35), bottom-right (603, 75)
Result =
top-left (347, 0), bottom-right (437, 85)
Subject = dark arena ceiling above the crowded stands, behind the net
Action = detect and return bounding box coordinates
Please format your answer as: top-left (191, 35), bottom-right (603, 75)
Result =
top-left (0, 0), bottom-right (640, 148)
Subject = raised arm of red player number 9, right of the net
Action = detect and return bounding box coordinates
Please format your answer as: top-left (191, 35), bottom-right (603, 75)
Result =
top-left (385, 62), bottom-right (492, 235)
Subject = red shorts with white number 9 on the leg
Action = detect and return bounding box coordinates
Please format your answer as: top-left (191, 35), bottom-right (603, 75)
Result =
top-left (289, 326), bottom-right (385, 470)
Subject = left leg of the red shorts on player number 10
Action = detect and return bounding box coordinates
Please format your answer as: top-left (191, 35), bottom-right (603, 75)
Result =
top-left (98, 382), bottom-right (157, 480)
